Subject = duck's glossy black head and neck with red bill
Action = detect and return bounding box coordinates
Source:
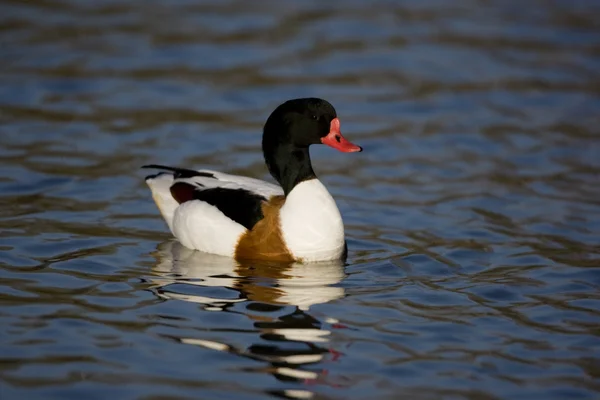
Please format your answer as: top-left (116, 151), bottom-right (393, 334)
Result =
top-left (262, 98), bottom-right (362, 194)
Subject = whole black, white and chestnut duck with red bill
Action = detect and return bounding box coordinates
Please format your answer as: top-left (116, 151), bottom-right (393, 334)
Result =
top-left (142, 98), bottom-right (362, 263)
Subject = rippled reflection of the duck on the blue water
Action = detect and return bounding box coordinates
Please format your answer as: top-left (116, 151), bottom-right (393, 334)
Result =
top-left (151, 241), bottom-right (345, 398)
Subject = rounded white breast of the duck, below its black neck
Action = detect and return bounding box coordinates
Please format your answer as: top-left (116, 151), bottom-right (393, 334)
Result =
top-left (280, 178), bottom-right (344, 261)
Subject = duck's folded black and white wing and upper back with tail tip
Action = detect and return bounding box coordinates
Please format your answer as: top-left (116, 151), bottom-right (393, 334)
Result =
top-left (143, 165), bottom-right (283, 229)
